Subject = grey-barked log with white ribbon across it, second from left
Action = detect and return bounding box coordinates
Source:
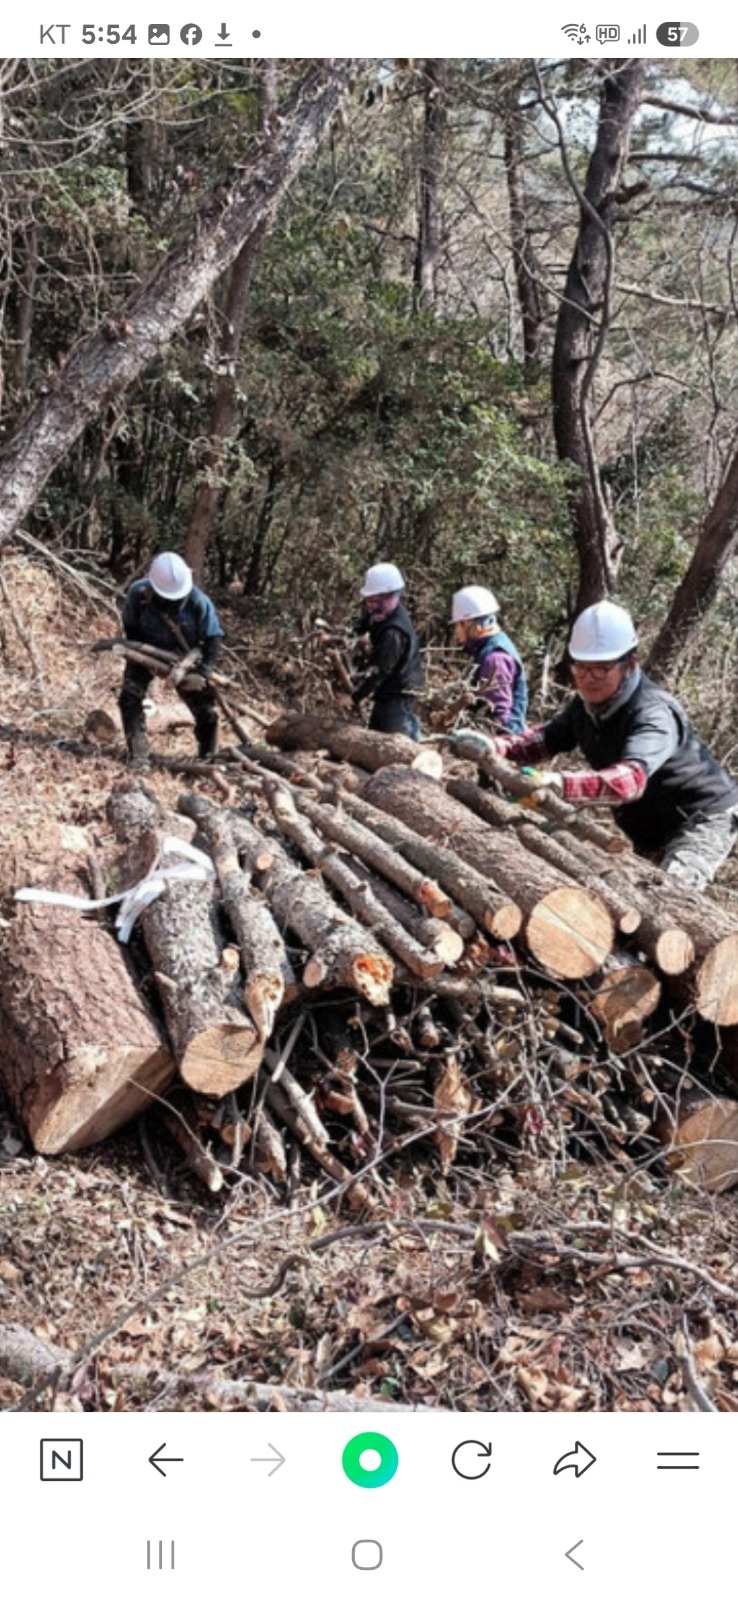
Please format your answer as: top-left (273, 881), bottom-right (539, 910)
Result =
top-left (107, 784), bottom-right (263, 1098)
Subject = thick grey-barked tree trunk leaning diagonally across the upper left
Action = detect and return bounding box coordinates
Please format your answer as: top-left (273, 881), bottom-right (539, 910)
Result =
top-left (0, 59), bottom-right (371, 544)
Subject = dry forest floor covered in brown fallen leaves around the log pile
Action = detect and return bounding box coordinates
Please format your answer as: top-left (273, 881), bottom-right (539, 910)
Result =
top-left (0, 555), bottom-right (738, 1411)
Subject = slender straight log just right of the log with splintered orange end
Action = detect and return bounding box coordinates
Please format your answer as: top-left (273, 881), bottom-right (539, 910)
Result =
top-left (264, 778), bottom-right (442, 986)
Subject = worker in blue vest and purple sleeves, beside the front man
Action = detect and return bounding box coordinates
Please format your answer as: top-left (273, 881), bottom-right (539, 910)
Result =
top-left (451, 584), bottom-right (528, 733)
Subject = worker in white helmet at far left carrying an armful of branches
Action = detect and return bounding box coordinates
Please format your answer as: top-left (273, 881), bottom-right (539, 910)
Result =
top-left (118, 550), bottom-right (223, 766)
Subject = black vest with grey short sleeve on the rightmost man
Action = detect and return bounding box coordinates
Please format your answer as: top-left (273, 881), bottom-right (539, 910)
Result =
top-left (541, 674), bottom-right (738, 853)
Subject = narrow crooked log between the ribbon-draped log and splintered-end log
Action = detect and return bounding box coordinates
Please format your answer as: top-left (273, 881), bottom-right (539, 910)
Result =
top-left (179, 794), bottom-right (296, 1042)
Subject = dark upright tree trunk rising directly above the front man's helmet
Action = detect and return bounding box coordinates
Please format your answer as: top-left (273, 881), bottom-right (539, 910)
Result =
top-left (552, 61), bottom-right (644, 613)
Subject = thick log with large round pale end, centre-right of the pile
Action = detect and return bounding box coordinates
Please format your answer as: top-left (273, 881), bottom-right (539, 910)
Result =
top-left (363, 766), bottom-right (613, 978)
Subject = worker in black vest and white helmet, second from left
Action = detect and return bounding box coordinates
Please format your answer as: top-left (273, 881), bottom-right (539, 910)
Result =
top-left (352, 562), bottom-right (423, 739)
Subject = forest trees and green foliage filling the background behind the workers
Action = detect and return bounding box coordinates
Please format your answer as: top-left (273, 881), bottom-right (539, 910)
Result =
top-left (0, 61), bottom-right (738, 681)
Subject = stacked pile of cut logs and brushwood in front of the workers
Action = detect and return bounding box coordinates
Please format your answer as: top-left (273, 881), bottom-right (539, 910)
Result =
top-left (0, 718), bottom-right (738, 1206)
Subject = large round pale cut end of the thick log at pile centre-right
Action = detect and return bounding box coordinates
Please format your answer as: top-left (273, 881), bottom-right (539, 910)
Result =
top-left (525, 888), bottom-right (613, 978)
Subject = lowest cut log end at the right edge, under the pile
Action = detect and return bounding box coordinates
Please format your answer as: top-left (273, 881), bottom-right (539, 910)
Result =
top-left (656, 1090), bottom-right (738, 1194)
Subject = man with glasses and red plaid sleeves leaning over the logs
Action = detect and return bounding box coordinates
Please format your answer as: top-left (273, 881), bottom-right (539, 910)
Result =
top-left (495, 600), bottom-right (738, 888)
